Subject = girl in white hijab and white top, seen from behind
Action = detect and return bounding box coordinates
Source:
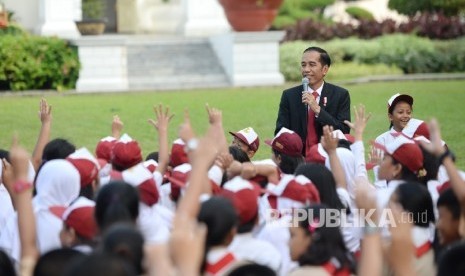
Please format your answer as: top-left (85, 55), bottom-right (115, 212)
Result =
top-left (0, 159), bottom-right (80, 262)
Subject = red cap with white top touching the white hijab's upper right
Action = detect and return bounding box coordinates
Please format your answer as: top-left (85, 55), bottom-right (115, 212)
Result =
top-left (66, 148), bottom-right (100, 187)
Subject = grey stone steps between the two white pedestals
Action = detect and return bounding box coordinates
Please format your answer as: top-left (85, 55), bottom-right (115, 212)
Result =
top-left (127, 40), bottom-right (230, 90)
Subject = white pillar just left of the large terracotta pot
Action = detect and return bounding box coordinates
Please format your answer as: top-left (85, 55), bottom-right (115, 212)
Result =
top-left (183, 0), bottom-right (231, 37)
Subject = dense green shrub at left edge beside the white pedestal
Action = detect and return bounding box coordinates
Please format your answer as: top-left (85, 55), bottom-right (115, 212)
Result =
top-left (0, 35), bottom-right (80, 90)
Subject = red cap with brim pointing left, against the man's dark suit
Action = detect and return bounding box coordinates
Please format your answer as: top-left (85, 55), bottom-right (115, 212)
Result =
top-left (265, 127), bottom-right (303, 156)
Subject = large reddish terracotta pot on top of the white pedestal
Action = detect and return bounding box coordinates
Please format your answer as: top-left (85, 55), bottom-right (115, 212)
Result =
top-left (219, 0), bottom-right (283, 32)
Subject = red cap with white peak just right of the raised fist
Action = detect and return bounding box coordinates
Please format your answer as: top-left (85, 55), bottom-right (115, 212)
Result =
top-left (111, 134), bottom-right (142, 169)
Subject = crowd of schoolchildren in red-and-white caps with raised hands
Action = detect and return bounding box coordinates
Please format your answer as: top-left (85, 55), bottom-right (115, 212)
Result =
top-left (0, 94), bottom-right (465, 276)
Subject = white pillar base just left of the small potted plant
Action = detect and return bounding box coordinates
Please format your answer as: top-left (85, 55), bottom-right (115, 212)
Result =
top-left (36, 0), bottom-right (81, 38)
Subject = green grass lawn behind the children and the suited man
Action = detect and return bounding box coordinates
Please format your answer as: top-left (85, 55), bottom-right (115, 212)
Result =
top-left (0, 80), bottom-right (465, 167)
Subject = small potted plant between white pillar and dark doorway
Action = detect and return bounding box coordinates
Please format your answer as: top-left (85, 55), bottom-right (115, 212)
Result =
top-left (76, 0), bottom-right (105, 35)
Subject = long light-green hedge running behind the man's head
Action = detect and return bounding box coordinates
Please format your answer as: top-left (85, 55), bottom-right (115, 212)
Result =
top-left (280, 34), bottom-right (465, 81)
